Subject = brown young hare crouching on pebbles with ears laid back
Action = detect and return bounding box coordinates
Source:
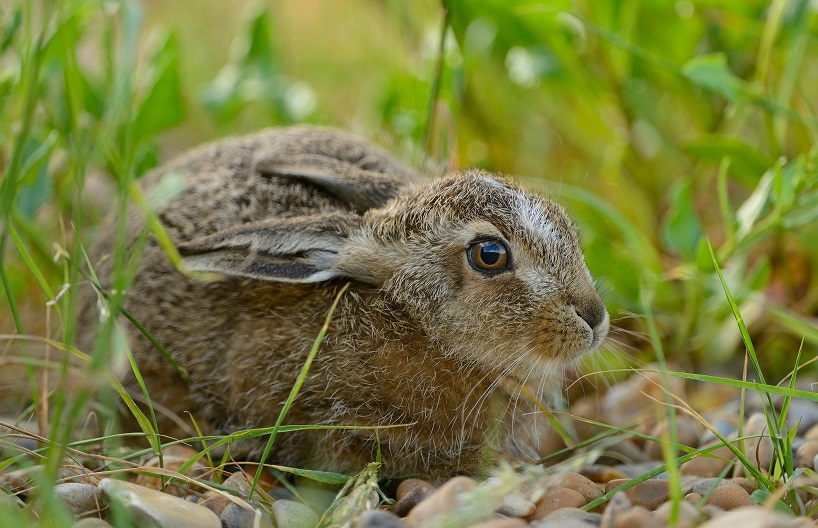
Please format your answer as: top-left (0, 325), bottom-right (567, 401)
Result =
top-left (83, 126), bottom-right (609, 482)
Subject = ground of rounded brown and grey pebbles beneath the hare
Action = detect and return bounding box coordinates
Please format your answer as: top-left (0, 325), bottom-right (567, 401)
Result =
top-left (0, 372), bottom-right (818, 528)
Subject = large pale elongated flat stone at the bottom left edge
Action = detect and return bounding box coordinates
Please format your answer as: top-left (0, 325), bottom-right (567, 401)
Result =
top-left (99, 478), bottom-right (222, 528)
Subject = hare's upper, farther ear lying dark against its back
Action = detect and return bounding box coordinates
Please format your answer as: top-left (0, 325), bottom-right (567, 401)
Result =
top-left (255, 153), bottom-right (422, 213)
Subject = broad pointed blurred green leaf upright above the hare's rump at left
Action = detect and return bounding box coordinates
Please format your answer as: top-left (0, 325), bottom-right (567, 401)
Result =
top-left (133, 35), bottom-right (184, 139)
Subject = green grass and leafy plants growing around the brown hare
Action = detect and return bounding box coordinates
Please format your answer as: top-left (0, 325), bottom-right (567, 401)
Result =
top-left (0, 0), bottom-right (818, 524)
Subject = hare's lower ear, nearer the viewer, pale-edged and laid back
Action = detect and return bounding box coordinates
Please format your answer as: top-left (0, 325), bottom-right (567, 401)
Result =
top-left (178, 213), bottom-right (371, 283)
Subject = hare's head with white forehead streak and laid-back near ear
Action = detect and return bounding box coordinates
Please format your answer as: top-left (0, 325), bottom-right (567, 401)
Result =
top-left (180, 165), bottom-right (608, 382)
